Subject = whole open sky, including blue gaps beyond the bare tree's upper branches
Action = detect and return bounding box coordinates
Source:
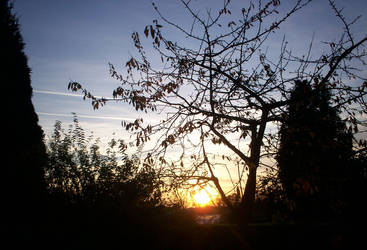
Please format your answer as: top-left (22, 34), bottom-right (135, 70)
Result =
top-left (14, 0), bottom-right (367, 192)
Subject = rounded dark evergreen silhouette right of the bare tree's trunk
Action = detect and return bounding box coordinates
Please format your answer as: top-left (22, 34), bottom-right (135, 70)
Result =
top-left (276, 81), bottom-right (353, 221)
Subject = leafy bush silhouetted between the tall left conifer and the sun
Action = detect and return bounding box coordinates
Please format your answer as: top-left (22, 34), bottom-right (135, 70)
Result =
top-left (45, 117), bottom-right (162, 219)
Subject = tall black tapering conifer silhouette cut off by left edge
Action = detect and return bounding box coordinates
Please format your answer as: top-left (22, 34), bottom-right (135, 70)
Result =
top-left (0, 0), bottom-right (47, 222)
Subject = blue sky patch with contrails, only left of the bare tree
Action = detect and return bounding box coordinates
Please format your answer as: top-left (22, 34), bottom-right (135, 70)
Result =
top-left (14, 0), bottom-right (158, 141)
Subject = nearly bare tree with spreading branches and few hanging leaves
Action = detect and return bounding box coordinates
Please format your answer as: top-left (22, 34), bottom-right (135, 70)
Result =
top-left (69, 0), bottom-right (367, 225)
